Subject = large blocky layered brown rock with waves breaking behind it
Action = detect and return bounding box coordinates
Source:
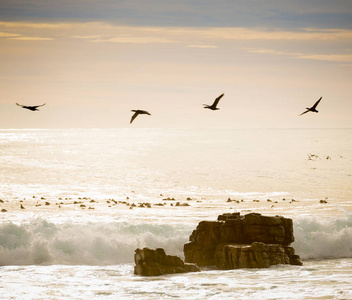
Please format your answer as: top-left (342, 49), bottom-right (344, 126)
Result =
top-left (184, 213), bottom-right (302, 269)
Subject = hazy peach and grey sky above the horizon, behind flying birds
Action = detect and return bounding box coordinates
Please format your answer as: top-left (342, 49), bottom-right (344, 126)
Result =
top-left (0, 0), bottom-right (352, 129)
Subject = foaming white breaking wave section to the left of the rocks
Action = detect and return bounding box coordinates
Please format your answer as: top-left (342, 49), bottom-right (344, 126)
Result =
top-left (0, 219), bottom-right (192, 265)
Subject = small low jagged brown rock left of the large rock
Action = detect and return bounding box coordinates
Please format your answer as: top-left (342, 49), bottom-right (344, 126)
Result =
top-left (134, 248), bottom-right (200, 276)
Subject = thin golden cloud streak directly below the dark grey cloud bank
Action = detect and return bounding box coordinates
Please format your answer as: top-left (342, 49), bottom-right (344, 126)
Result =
top-left (0, 22), bottom-right (352, 46)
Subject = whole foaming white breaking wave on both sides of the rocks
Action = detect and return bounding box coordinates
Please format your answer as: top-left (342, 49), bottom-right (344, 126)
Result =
top-left (0, 214), bottom-right (352, 265)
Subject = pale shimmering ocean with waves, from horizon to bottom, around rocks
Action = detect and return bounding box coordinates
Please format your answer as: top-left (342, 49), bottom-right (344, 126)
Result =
top-left (0, 128), bottom-right (352, 299)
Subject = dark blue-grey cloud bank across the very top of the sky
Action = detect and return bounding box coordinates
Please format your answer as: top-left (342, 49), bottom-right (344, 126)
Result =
top-left (0, 0), bottom-right (352, 28)
